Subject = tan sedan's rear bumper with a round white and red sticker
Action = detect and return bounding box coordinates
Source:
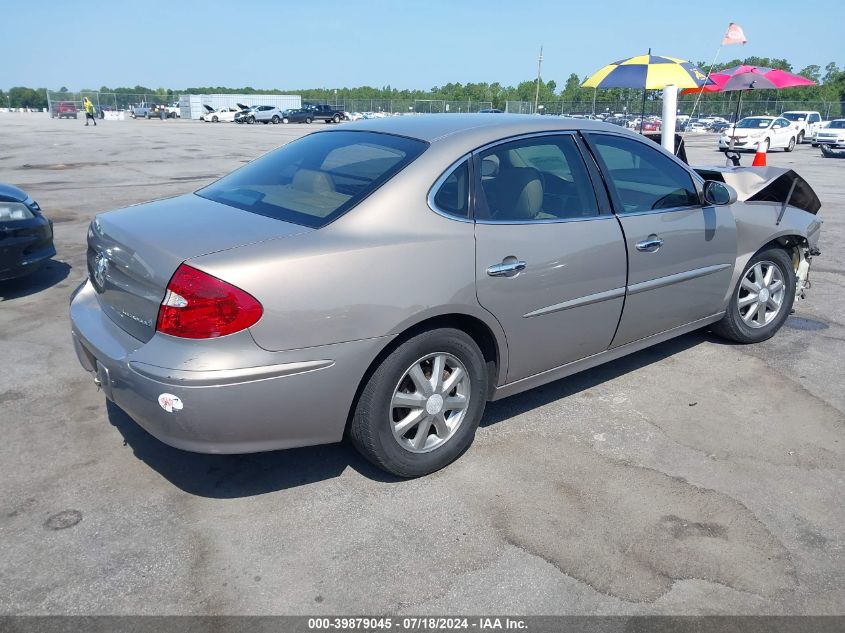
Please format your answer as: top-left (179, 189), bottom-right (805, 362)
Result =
top-left (70, 282), bottom-right (385, 453)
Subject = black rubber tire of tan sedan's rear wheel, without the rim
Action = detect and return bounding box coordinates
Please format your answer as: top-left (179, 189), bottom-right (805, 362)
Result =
top-left (350, 328), bottom-right (488, 477)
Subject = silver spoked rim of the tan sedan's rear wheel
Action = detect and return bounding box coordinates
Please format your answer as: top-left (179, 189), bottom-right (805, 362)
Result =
top-left (390, 352), bottom-right (471, 453)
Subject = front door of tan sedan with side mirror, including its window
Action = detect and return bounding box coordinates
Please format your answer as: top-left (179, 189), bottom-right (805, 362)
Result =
top-left (586, 132), bottom-right (737, 347)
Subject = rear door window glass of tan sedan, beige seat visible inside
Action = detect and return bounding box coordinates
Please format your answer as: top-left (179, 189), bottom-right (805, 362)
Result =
top-left (478, 134), bottom-right (599, 222)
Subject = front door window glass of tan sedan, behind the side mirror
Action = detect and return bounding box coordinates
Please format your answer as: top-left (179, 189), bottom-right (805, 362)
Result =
top-left (590, 134), bottom-right (701, 213)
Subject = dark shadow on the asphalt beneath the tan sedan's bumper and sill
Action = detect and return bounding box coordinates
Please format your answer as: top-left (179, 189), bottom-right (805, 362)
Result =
top-left (107, 332), bottom-right (716, 499)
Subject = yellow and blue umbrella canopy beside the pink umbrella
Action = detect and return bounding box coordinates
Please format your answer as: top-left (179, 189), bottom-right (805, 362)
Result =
top-left (581, 51), bottom-right (711, 90)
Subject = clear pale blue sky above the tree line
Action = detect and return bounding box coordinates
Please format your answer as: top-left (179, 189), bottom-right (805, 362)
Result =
top-left (0, 0), bottom-right (845, 90)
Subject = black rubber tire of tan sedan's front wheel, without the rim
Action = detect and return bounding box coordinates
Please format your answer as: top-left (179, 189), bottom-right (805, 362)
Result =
top-left (711, 247), bottom-right (795, 343)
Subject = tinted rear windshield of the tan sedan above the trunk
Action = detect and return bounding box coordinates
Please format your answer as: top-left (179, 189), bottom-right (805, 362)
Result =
top-left (196, 132), bottom-right (428, 228)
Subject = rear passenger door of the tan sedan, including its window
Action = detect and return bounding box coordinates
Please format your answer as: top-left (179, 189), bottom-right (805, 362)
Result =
top-left (474, 133), bottom-right (626, 382)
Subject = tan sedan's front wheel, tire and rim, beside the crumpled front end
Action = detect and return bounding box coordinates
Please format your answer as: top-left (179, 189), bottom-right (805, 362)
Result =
top-left (712, 248), bottom-right (795, 343)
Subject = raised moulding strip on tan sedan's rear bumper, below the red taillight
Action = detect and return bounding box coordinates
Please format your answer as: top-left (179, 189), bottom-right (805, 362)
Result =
top-left (129, 360), bottom-right (334, 387)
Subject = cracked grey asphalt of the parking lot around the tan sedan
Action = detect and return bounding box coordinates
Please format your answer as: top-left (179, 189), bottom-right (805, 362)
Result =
top-left (0, 113), bottom-right (845, 614)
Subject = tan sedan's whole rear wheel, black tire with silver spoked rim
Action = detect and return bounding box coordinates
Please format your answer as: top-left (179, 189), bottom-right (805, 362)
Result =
top-left (350, 328), bottom-right (488, 477)
